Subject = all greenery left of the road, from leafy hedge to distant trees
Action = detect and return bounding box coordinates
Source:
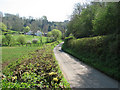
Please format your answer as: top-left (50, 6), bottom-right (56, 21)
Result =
top-left (0, 2), bottom-right (70, 89)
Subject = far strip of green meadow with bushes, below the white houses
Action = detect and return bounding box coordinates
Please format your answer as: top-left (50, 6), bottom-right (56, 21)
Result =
top-left (0, 34), bottom-right (47, 46)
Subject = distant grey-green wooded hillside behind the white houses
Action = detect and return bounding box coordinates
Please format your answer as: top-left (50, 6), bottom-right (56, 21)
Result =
top-left (2, 13), bottom-right (68, 33)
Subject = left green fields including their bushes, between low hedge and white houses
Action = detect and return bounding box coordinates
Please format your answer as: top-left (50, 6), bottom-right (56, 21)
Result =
top-left (1, 34), bottom-right (46, 66)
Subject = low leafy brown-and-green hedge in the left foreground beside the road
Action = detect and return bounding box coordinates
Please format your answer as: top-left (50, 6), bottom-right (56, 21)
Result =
top-left (2, 42), bottom-right (69, 89)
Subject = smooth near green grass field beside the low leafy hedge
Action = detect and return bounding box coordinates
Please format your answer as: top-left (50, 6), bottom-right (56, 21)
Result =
top-left (0, 47), bottom-right (38, 63)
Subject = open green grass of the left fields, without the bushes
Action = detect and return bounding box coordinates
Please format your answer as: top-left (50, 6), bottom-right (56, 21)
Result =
top-left (0, 35), bottom-right (47, 66)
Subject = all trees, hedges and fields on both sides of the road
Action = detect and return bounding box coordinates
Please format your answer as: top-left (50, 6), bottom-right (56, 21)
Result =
top-left (0, 2), bottom-right (120, 89)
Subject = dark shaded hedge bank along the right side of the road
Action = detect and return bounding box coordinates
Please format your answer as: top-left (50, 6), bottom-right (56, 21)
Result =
top-left (62, 35), bottom-right (120, 81)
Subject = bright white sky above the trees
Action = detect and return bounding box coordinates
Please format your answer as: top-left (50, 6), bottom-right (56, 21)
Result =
top-left (0, 0), bottom-right (89, 21)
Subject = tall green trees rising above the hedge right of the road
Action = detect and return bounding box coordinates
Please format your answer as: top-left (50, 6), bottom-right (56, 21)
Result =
top-left (66, 2), bottom-right (120, 38)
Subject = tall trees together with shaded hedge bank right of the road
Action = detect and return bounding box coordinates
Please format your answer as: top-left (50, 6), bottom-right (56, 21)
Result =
top-left (62, 2), bottom-right (120, 81)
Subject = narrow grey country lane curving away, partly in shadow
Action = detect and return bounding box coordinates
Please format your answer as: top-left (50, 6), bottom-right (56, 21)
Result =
top-left (53, 43), bottom-right (120, 88)
